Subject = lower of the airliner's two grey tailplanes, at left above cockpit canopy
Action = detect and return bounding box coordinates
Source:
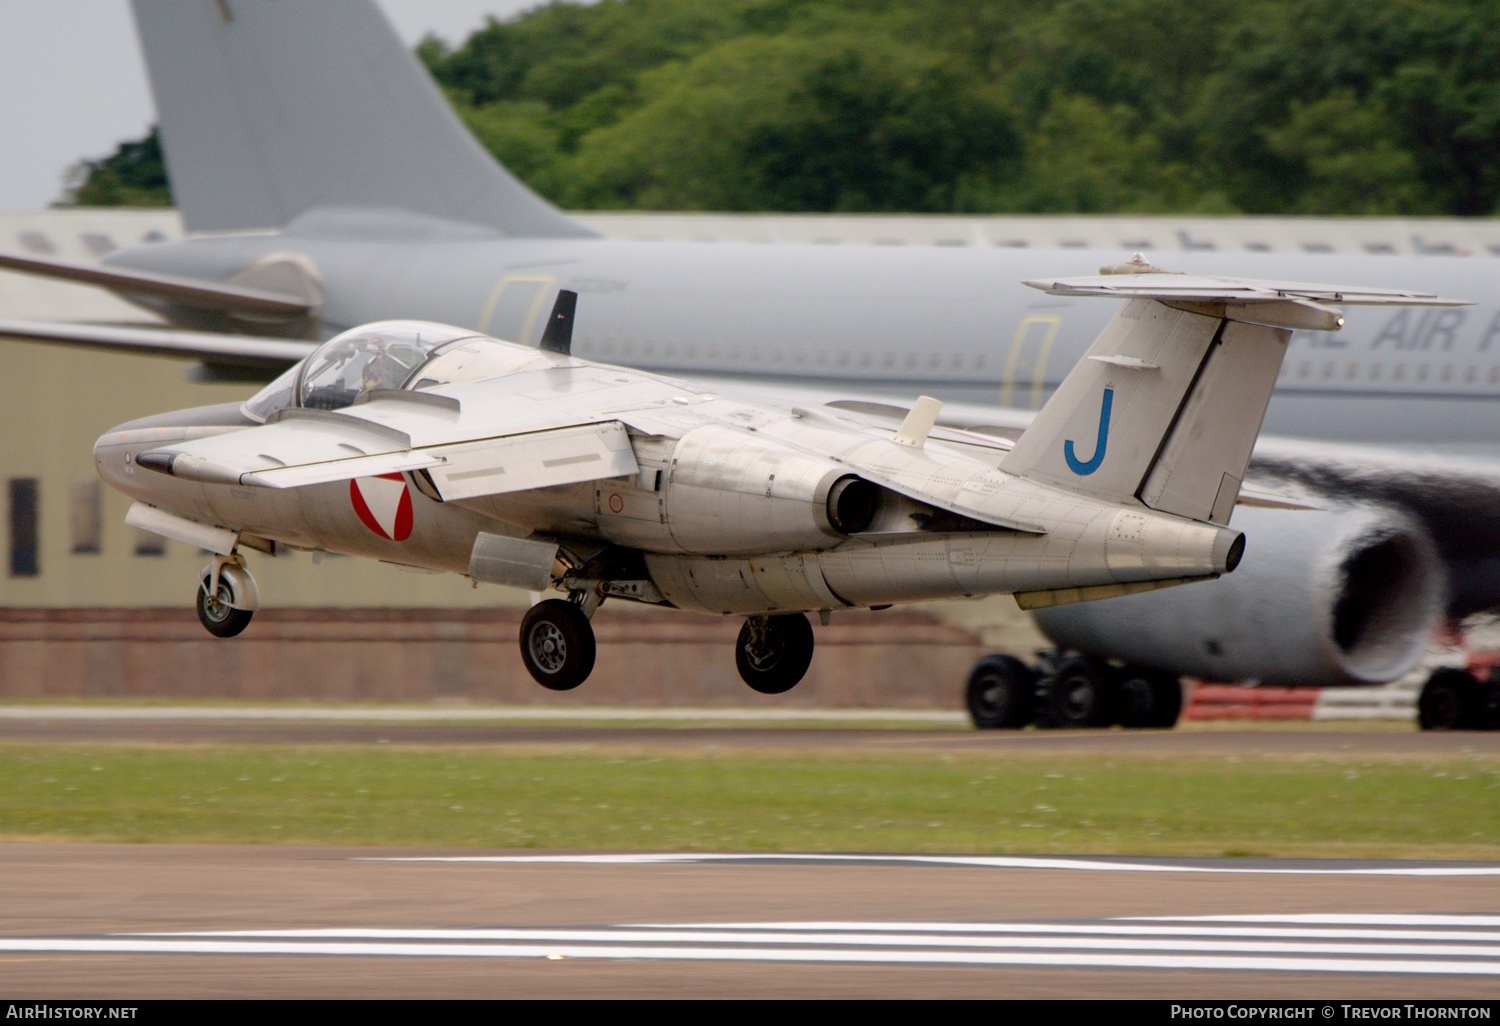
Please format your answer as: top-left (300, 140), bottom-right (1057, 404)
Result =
top-left (0, 320), bottom-right (318, 372)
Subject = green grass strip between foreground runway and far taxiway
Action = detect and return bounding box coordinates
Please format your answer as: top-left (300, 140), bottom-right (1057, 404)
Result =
top-left (0, 744), bottom-right (1500, 860)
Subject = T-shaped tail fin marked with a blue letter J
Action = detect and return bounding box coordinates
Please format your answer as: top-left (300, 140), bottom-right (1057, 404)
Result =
top-left (1001, 269), bottom-right (1455, 524)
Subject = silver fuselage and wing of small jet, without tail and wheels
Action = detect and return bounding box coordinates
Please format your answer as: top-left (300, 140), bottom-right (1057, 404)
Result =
top-left (95, 322), bottom-right (1239, 615)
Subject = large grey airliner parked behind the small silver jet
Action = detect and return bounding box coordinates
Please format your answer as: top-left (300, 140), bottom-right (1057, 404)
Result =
top-left (0, 0), bottom-right (1500, 729)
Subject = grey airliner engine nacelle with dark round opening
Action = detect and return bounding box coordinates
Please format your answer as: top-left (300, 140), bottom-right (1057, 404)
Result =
top-left (1037, 507), bottom-right (1445, 687)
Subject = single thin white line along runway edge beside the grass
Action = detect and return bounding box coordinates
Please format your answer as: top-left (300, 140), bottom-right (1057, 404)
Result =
top-left (353, 852), bottom-right (1500, 876)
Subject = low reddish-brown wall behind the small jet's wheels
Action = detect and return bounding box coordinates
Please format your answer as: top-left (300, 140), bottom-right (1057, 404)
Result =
top-left (0, 606), bottom-right (987, 710)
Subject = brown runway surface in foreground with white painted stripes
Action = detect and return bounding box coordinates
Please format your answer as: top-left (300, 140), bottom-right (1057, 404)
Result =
top-left (0, 843), bottom-right (1500, 999)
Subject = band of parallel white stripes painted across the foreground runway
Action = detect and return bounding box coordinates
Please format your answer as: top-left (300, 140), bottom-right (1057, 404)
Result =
top-left (0, 915), bottom-right (1500, 977)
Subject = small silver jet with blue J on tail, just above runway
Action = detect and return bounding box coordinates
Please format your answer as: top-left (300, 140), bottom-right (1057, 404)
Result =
top-left (95, 272), bottom-right (1454, 702)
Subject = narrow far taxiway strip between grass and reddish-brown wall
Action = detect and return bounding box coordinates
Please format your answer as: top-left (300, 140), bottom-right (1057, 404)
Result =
top-left (0, 705), bottom-right (1500, 758)
